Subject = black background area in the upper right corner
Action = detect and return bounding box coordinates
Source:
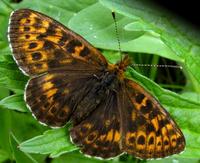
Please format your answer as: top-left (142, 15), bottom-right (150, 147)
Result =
top-left (152, 0), bottom-right (200, 27)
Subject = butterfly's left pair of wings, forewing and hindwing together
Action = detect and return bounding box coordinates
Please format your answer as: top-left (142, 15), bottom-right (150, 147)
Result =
top-left (8, 9), bottom-right (107, 127)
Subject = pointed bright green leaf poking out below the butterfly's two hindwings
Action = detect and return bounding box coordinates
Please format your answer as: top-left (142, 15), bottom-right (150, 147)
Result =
top-left (19, 128), bottom-right (77, 157)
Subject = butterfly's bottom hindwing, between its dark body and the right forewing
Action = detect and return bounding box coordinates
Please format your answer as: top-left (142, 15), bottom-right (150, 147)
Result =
top-left (70, 91), bottom-right (122, 158)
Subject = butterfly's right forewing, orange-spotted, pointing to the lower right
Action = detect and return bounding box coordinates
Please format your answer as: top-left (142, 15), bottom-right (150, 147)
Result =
top-left (118, 79), bottom-right (185, 159)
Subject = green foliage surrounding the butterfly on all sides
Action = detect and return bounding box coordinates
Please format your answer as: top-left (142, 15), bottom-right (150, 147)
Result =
top-left (0, 0), bottom-right (200, 163)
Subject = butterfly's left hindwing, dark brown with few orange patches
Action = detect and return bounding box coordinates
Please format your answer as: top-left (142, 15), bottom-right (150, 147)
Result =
top-left (25, 72), bottom-right (101, 127)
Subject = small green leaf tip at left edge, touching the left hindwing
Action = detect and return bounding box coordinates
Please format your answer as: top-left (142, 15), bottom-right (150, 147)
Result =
top-left (0, 94), bottom-right (28, 112)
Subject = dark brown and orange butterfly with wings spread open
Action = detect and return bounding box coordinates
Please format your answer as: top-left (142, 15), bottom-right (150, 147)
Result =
top-left (8, 9), bottom-right (185, 159)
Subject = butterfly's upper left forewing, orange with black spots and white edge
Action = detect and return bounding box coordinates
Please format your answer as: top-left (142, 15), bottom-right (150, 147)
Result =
top-left (8, 9), bottom-right (107, 76)
